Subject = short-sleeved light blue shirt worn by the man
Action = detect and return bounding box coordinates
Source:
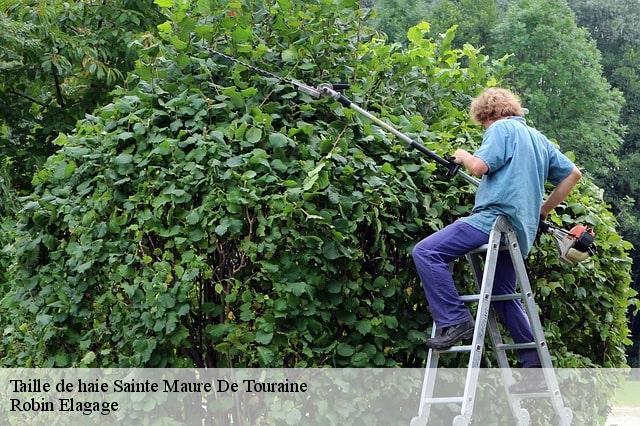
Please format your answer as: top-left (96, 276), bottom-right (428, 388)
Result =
top-left (460, 117), bottom-right (575, 256)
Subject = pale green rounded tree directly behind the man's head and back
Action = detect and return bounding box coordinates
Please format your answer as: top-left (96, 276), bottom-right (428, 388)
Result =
top-left (491, 0), bottom-right (623, 182)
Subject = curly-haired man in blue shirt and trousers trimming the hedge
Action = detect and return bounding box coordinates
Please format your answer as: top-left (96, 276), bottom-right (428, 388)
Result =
top-left (413, 88), bottom-right (582, 367)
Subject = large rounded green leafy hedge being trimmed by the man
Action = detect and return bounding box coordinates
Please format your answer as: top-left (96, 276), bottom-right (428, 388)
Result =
top-left (0, 0), bottom-right (633, 367)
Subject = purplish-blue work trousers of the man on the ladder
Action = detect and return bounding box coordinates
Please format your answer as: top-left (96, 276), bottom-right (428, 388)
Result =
top-left (412, 221), bottom-right (540, 368)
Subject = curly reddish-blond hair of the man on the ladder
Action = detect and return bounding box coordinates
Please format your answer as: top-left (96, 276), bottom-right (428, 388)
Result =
top-left (469, 87), bottom-right (524, 124)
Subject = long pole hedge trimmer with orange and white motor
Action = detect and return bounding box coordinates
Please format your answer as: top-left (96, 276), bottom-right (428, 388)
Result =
top-left (205, 47), bottom-right (596, 264)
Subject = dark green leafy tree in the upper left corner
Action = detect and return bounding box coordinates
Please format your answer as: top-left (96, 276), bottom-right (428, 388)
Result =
top-left (0, 0), bottom-right (160, 191)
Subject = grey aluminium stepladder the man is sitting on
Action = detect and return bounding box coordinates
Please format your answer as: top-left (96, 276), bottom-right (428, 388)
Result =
top-left (411, 216), bottom-right (573, 426)
